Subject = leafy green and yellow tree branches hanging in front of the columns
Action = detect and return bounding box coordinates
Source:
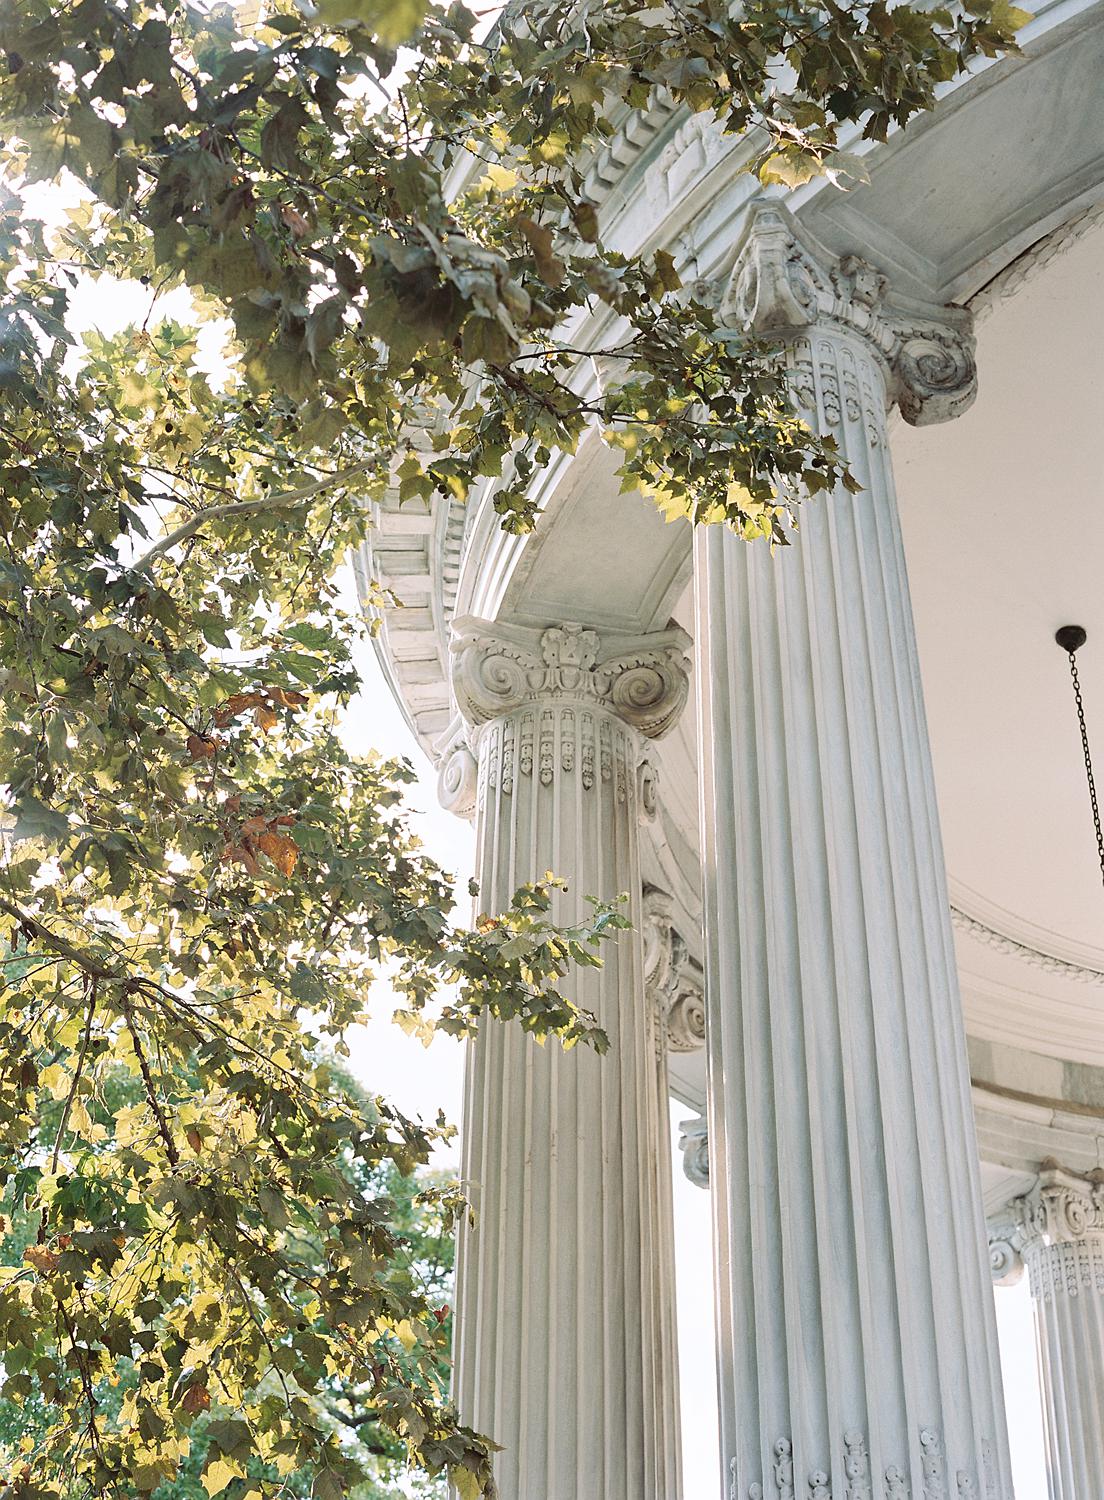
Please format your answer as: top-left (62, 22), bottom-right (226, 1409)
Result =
top-left (0, 0), bottom-right (1025, 1500)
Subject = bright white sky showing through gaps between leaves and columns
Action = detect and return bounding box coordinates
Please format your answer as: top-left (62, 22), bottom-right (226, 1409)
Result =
top-left (27, 172), bottom-right (1047, 1500)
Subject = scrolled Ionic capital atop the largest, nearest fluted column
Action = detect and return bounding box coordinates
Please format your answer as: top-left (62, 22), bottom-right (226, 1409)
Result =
top-left (720, 198), bottom-right (978, 428)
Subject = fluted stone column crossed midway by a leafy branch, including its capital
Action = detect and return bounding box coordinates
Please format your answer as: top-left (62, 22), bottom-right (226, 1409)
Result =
top-left (443, 620), bottom-right (689, 1500)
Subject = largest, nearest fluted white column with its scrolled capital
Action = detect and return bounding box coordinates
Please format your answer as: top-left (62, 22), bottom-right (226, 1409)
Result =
top-left (696, 203), bottom-right (1011, 1500)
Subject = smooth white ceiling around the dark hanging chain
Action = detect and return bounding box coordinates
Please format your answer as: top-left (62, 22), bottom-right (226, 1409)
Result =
top-left (893, 214), bottom-right (1104, 960)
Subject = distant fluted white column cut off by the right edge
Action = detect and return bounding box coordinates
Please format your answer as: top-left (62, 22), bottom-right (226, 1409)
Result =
top-left (990, 1163), bottom-right (1104, 1500)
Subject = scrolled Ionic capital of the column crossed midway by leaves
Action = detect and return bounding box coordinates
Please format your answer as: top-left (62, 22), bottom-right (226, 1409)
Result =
top-left (452, 617), bottom-right (690, 740)
